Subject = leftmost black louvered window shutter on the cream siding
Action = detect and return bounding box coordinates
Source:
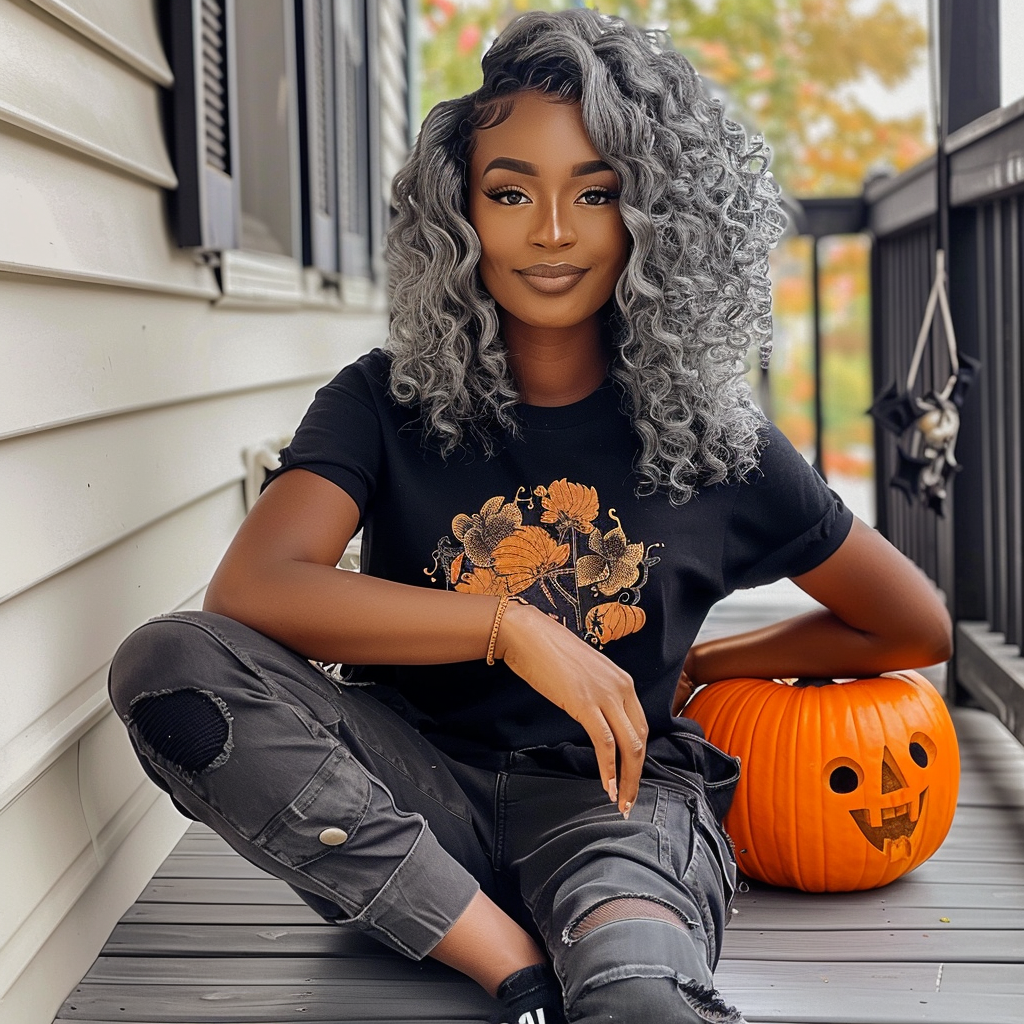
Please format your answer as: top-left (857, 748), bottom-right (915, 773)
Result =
top-left (164, 0), bottom-right (241, 249)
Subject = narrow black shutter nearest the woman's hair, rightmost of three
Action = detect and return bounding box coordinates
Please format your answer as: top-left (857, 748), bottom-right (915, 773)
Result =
top-left (335, 0), bottom-right (372, 278)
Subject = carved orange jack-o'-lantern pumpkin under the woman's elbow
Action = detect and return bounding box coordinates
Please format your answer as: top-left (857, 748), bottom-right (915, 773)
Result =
top-left (684, 672), bottom-right (959, 892)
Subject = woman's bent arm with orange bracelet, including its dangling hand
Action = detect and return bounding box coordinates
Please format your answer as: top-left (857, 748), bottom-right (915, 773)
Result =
top-left (204, 469), bottom-right (647, 810)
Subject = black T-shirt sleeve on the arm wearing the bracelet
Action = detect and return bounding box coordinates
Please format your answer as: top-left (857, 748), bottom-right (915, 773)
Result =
top-left (263, 351), bottom-right (386, 519)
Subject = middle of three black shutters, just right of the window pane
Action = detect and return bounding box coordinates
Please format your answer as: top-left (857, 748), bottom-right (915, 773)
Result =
top-left (295, 0), bottom-right (338, 271)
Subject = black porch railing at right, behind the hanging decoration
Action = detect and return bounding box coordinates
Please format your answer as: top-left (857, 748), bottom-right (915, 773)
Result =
top-left (865, 94), bottom-right (1024, 739)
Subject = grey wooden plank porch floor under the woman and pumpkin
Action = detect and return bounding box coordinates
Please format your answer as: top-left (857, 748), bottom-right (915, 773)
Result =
top-left (56, 588), bottom-right (1024, 1024)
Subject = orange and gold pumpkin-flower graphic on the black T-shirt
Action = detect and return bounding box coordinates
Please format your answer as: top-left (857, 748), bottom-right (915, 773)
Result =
top-left (423, 477), bottom-right (663, 647)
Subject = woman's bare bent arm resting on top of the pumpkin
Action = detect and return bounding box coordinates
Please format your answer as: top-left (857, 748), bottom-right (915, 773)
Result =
top-left (674, 519), bottom-right (952, 711)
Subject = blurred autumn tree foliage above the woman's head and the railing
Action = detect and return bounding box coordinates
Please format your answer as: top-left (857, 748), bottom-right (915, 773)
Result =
top-left (420, 0), bottom-right (930, 197)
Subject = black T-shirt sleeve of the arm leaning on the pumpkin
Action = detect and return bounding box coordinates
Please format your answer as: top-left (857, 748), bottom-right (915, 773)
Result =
top-left (723, 424), bottom-right (853, 592)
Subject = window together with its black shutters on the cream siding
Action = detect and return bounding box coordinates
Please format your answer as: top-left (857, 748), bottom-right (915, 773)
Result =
top-left (163, 0), bottom-right (410, 280)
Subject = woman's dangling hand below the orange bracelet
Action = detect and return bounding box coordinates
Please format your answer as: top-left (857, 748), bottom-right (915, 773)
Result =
top-left (495, 602), bottom-right (647, 817)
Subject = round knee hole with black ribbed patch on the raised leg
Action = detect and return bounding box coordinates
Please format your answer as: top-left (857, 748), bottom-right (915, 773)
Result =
top-left (128, 688), bottom-right (231, 772)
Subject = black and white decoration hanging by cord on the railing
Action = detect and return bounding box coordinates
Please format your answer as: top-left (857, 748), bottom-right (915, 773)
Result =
top-left (868, 249), bottom-right (981, 515)
